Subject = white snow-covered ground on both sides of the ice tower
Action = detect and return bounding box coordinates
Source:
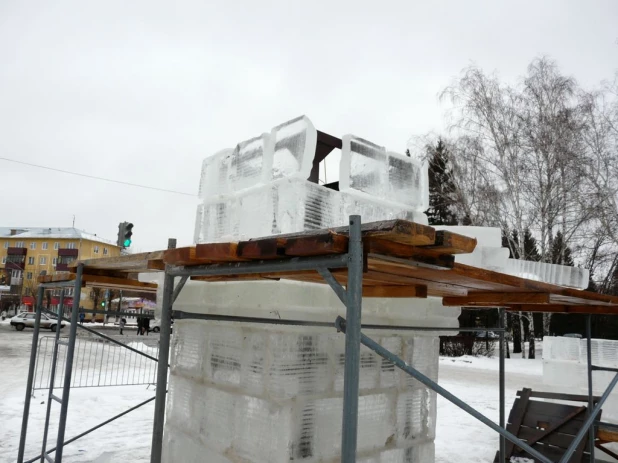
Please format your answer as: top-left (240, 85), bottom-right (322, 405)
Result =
top-left (0, 322), bottom-right (544, 463)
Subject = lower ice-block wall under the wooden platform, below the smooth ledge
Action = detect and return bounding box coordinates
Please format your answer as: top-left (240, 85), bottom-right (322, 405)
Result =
top-left (165, 321), bottom-right (439, 463)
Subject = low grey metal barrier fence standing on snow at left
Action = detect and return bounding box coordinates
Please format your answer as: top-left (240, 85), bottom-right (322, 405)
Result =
top-left (32, 336), bottom-right (159, 391)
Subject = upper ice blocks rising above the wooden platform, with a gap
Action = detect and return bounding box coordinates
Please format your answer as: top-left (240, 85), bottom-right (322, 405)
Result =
top-left (195, 116), bottom-right (428, 243)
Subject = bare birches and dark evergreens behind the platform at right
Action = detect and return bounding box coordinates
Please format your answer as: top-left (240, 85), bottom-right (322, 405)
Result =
top-left (415, 57), bottom-right (618, 355)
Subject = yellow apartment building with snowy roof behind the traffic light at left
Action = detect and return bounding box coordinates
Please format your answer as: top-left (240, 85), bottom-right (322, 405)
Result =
top-left (0, 227), bottom-right (121, 309)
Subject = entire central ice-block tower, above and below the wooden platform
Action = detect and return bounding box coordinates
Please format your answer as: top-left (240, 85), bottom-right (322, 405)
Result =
top-left (163, 116), bottom-right (592, 463)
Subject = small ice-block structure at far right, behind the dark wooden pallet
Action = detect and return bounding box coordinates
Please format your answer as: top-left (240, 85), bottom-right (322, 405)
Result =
top-left (543, 336), bottom-right (618, 422)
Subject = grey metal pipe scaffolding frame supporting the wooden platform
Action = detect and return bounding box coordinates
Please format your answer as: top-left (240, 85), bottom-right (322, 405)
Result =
top-left (18, 215), bottom-right (618, 463)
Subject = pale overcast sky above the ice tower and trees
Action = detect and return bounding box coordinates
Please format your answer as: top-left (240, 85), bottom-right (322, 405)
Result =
top-left (0, 0), bottom-right (618, 250)
